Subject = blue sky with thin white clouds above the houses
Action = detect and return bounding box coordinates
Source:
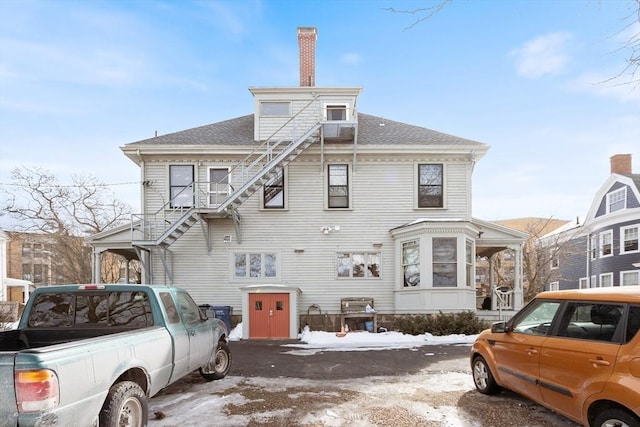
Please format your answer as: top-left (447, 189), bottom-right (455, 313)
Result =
top-left (0, 0), bottom-right (640, 226)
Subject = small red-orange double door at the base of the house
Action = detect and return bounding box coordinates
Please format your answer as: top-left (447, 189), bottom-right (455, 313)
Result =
top-left (249, 294), bottom-right (289, 338)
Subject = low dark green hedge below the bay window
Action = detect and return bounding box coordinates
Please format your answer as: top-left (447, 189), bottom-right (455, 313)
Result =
top-left (393, 311), bottom-right (490, 336)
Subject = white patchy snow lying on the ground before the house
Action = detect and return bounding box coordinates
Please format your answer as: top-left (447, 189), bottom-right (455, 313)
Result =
top-left (149, 324), bottom-right (480, 427)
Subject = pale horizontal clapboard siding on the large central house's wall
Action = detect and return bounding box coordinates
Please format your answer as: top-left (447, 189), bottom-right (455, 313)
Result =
top-left (144, 153), bottom-right (478, 314)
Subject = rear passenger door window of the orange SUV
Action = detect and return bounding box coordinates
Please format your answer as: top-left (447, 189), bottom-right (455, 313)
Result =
top-left (558, 302), bottom-right (624, 342)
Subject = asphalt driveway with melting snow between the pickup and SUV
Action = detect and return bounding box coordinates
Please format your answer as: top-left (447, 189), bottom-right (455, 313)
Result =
top-left (149, 340), bottom-right (578, 427)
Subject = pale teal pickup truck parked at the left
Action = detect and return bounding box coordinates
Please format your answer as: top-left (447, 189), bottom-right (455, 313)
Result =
top-left (0, 285), bottom-right (231, 427)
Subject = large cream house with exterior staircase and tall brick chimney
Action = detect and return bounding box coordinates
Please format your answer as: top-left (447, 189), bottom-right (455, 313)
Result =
top-left (87, 28), bottom-right (526, 338)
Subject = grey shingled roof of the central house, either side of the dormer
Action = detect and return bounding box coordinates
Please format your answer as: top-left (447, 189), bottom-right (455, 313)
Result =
top-left (127, 113), bottom-right (484, 147)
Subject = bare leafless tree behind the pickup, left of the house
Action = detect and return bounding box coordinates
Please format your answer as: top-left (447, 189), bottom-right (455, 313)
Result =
top-left (0, 167), bottom-right (131, 283)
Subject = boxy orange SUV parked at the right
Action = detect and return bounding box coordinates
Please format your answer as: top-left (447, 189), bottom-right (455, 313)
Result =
top-left (471, 286), bottom-right (640, 427)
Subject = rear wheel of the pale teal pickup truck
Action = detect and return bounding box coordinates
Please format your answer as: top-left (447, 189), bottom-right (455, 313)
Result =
top-left (100, 381), bottom-right (149, 427)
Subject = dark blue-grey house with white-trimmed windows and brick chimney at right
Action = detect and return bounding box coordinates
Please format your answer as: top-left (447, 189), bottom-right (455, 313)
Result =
top-left (542, 154), bottom-right (640, 289)
